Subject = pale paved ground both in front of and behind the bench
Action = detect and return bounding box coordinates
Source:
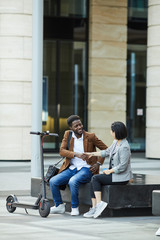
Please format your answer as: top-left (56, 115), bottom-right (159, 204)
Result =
top-left (0, 154), bottom-right (160, 240)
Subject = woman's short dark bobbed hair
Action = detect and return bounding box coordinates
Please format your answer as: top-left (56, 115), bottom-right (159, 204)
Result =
top-left (111, 122), bottom-right (128, 140)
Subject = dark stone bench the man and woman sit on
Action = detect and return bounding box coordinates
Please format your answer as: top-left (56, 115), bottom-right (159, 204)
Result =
top-left (31, 174), bottom-right (160, 216)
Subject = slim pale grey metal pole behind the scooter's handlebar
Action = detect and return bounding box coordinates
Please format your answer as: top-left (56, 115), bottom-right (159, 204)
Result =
top-left (31, 0), bottom-right (43, 178)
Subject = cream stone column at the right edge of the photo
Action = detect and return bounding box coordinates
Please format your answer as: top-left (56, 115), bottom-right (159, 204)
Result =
top-left (146, 0), bottom-right (160, 158)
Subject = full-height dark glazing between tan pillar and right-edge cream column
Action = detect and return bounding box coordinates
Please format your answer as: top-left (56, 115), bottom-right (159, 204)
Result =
top-left (127, 0), bottom-right (147, 151)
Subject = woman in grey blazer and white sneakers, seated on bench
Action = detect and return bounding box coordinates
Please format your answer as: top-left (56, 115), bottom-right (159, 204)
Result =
top-left (83, 122), bottom-right (133, 218)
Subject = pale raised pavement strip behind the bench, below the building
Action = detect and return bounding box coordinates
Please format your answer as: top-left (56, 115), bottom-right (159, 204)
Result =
top-left (0, 153), bottom-right (160, 196)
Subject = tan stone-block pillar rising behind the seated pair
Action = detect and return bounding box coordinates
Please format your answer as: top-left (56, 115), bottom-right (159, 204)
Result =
top-left (88, 0), bottom-right (127, 144)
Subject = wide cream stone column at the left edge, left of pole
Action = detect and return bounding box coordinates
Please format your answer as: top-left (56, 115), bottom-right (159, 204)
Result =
top-left (0, 0), bottom-right (32, 160)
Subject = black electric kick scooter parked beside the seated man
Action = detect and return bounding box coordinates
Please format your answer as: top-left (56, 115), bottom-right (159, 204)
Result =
top-left (6, 131), bottom-right (58, 217)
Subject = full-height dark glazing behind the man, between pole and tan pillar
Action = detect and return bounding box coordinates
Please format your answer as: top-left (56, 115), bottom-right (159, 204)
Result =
top-left (42, 0), bottom-right (88, 152)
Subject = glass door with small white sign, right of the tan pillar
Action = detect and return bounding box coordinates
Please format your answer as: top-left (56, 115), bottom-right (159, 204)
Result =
top-left (127, 45), bottom-right (146, 151)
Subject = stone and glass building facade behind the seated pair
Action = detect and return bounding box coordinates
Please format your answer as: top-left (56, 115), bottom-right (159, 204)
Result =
top-left (0, 0), bottom-right (160, 163)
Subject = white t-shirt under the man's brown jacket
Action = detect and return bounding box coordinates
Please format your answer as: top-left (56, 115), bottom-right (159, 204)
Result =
top-left (69, 132), bottom-right (90, 170)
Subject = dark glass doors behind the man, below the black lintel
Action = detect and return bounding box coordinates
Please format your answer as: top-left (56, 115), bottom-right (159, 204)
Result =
top-left (42, 40), bottom-right (87, 151)
